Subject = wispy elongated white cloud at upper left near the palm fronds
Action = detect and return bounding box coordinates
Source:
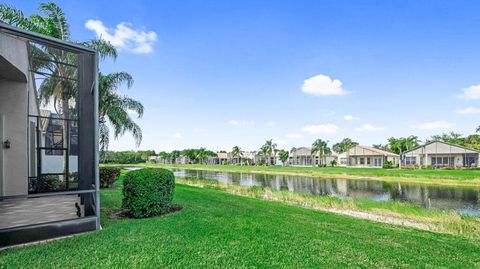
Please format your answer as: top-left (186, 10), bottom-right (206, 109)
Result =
top-left (85, 20), bottom-right (157, 54)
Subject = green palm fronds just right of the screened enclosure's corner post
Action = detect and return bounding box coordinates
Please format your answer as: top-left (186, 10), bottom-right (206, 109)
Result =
top-left (98, 72), bottom-right (143, 151)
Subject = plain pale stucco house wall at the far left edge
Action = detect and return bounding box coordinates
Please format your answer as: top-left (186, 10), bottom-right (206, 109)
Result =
top-left (0, 34), bottom-right (28, 196)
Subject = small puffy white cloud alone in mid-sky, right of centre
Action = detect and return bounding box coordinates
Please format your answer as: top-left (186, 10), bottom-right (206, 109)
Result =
top-left (302, 75), bottom-right (347, 96)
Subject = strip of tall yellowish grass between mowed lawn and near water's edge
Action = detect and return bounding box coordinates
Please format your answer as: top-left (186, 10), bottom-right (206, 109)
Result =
top-left (177, 178), bottom-right (480, 238)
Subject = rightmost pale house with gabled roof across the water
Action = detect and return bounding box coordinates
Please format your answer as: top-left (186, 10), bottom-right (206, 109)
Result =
top-left (402, 141), bottom-right (480, 167)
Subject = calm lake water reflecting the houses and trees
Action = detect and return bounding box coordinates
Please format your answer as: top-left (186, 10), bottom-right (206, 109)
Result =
top-left (171, 169), bottom-right (480, 216)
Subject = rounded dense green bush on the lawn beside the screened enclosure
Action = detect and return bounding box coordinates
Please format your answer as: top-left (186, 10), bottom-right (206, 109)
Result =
top-left (123, 168), bottom-right (175, 218)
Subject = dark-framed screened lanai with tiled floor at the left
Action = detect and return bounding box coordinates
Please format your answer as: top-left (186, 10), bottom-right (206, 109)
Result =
top-left (0, 23), bottom-right (100, 247)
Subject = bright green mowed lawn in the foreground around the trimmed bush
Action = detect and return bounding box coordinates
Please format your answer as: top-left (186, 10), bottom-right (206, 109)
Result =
top-left (0, 185), bottom-right (480, 268)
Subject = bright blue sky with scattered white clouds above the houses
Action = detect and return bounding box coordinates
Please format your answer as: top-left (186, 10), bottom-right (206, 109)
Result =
top-left (6, 0), bottom-right (480, 151)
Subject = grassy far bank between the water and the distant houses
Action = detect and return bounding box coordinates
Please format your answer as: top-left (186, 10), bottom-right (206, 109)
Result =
top-left (107, 164), bottom-right (480, 188)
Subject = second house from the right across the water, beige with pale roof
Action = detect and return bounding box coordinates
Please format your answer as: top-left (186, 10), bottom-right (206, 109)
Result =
top-left (339, 145), bottom-right (400, 167)
